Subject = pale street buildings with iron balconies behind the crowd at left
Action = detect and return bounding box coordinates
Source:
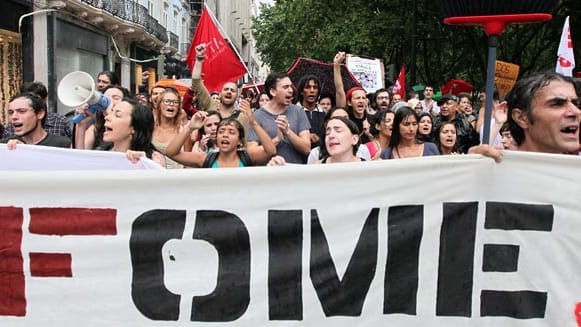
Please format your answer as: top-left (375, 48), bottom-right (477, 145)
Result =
top-left (0, 0), bottom-right (264, 123)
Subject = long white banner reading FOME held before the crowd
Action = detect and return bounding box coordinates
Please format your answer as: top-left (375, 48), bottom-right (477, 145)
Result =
top-left (0, 153), bottom-right (581, 327)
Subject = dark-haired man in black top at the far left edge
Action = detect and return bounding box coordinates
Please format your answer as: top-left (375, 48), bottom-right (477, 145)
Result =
top-left (0, 93), bottom-right (71, 148)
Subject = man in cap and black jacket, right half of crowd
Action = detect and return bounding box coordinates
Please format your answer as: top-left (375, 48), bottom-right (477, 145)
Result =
top-left (434, 94), bottom-right (480, 153)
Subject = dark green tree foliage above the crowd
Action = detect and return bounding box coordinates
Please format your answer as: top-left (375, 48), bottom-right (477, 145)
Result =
top-left (253, 0), bottom-right (581, 91)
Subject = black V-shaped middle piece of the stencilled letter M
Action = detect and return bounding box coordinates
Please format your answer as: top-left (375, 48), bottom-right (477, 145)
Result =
top-left (310, 208), bottom-right (379, 317)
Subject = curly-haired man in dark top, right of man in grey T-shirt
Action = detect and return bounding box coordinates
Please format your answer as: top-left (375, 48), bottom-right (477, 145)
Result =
top-left (297, 75), bottom-right (325, 148)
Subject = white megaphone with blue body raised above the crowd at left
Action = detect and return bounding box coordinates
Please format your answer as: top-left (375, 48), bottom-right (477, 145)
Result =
top-left (57, 71), bottom-right (111, 124)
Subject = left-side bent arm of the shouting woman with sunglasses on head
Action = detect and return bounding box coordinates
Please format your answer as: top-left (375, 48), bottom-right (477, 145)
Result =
top-left (165, 111), bottom-right (207, 167)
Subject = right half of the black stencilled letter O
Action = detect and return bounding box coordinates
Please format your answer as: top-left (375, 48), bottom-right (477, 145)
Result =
top-left (191, 210), bottom-right (250, 322)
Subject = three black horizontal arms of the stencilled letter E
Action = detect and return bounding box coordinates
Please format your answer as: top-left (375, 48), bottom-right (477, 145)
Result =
top-left (480, 202), bottom-right (554, 319)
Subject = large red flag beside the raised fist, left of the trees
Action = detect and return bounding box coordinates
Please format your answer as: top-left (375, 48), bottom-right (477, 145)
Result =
top-left (186, 7), bottom-right (246, 91)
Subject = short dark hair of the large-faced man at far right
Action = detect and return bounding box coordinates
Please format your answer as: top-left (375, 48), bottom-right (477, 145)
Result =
top-left (506, 71), bottom-right (579, 145)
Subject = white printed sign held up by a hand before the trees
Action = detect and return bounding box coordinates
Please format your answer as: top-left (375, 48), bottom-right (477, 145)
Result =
top-left (346, 55), bottom-right (385, 93)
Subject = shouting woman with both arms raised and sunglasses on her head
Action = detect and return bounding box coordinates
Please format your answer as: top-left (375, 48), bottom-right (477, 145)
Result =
top-left (166, 100), bottom-right (276, 168)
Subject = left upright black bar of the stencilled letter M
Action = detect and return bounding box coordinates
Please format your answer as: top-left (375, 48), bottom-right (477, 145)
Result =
top-left (268, 210), bottom-right (303, 320)
